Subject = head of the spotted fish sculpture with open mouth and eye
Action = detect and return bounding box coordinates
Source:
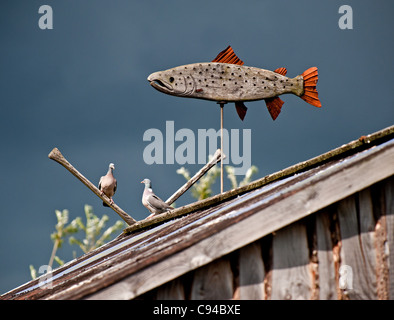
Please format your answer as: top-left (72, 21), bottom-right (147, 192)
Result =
top-left (148, 68), bottom-right (196, 96)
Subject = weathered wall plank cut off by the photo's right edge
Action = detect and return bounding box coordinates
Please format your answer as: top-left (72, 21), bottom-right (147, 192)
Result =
top-left (384, 176), bottom-right (394, 300)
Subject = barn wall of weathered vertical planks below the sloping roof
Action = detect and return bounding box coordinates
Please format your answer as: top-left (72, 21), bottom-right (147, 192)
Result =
top-left (137, 176), bottom-right (394, 300)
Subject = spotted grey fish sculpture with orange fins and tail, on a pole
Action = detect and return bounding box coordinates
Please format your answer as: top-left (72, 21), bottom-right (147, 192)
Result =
top-left (148, 46), bottom-right (321, 120)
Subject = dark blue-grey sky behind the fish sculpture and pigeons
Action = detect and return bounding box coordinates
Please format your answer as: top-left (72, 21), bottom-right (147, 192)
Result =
top-left (0, 0), bottom-right (394, 293)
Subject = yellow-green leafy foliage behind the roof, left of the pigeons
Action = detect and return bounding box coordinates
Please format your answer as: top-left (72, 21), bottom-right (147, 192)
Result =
top-left (29, 204), bottom-right (124, 279)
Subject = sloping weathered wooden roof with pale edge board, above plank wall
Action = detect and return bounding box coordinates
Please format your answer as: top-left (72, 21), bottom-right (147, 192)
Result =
top-left (0, 126), bottom-right (394, 299)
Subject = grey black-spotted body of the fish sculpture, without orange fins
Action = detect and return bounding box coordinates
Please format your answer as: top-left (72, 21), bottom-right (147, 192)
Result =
top-left (150, 62), bottom-right (304, 102)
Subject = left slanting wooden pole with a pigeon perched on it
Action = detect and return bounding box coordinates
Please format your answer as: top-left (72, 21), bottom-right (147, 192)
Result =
top-left (48, 148), bottom-right (137, 226)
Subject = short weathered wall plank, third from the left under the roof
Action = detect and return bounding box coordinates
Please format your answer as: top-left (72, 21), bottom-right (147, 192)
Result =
top-left (239, 241), bottom-right (265, 300)
